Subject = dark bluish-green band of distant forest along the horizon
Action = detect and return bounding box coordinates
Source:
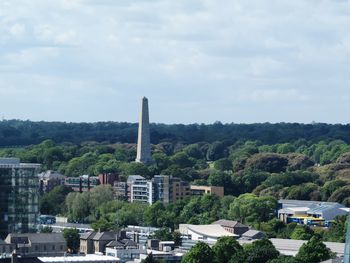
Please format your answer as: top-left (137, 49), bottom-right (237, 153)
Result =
top-left (0, 120), bottom-right (350, 147)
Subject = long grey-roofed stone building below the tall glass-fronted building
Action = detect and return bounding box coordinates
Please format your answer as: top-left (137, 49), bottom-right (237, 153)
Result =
top-left (5, 233), bottom-right (67, 257)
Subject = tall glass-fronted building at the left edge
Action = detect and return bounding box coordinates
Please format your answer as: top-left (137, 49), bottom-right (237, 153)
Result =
top-left (0, 158), bottom-right (40, 237)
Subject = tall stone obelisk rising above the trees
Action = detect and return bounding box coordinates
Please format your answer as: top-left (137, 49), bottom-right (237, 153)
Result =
top-left (135, 97), bottom-right (152, 164)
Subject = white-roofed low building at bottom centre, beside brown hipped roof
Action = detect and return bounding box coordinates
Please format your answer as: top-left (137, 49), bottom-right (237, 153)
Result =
top-left (179, 224), bottom-right (239, 242)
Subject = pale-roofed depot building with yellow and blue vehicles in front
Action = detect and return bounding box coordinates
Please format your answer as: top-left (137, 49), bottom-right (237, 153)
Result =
top-left (278, 200), bottom-right (349, 227)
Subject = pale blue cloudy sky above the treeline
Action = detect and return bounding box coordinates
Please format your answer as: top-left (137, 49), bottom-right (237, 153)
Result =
top-left (0, 0), bottom-right (350, 123)
